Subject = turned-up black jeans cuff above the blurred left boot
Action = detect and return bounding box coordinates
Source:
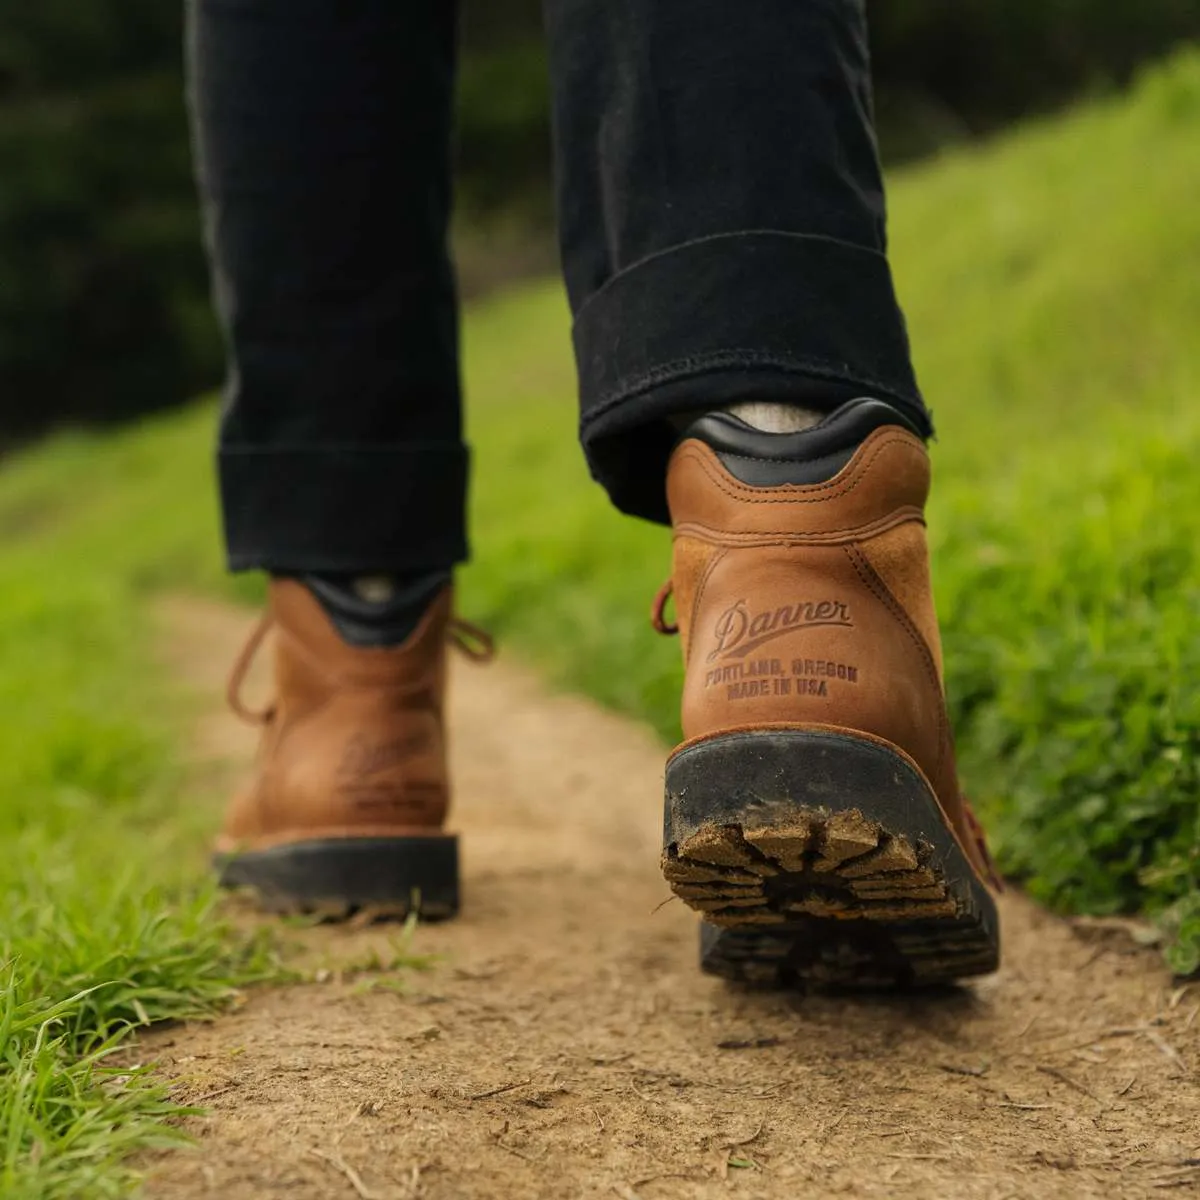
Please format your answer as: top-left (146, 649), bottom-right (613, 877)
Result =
top-left (220, 443), bottom-right (468, 572)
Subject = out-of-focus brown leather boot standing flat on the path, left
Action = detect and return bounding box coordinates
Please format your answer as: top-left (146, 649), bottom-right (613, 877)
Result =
top-left (216, 580), bottom-right (491, 918)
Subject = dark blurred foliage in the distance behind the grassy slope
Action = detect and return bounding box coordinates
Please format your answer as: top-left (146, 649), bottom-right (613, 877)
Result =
top-left (0, 0), bottom-right (1200, 450)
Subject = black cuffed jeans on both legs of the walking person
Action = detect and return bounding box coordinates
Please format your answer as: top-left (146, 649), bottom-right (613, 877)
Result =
top-left (188, 0), bottom-right (930, 571)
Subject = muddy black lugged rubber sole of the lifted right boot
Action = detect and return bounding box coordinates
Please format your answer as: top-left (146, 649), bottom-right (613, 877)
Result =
top-left (662, 730), bottom-right (1000, 988)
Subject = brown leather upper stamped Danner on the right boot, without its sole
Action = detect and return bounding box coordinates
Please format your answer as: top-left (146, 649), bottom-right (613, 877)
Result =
top-left (667, 426), bottom-right (990, 874)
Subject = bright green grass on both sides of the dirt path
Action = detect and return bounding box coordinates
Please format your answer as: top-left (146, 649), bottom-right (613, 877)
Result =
top-left (0, 44), bottom-right (1200, 1198)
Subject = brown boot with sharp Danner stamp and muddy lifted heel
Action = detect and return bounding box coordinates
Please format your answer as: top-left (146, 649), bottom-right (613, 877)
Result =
top-left (658, 400), bottom-right (998, 985)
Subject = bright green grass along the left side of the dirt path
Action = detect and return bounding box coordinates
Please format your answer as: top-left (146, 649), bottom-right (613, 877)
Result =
top-left (0, 429), bottom-right (278, 1200)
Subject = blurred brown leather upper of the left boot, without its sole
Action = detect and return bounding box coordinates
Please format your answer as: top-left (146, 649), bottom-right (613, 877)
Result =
top-left (217, 580), bottom-right (452, 852)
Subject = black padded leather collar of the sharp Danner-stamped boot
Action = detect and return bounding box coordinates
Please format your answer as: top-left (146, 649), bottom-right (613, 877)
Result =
top-left (684, 397), bottom-right (919, 487)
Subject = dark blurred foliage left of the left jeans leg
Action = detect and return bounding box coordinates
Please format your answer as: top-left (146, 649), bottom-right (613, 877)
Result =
top-left (0, 0), bottom-right (221, 449)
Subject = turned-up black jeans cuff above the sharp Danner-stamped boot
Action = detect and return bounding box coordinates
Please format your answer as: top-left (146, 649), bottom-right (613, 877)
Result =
top-left (574, 230), bottom-right (932, 521)
